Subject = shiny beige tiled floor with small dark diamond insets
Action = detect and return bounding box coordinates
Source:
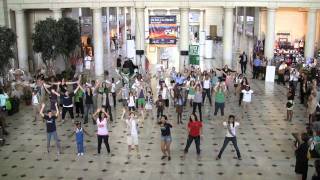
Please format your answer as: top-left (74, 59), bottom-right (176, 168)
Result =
top-left (0, 81), bottom-right (314, 180)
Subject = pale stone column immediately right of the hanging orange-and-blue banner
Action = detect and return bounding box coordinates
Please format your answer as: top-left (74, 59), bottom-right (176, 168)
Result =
top-left (176, 8), bottom-right (189, 72)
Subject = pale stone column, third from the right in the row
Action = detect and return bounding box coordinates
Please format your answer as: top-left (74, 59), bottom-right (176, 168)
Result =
top-left (223, 7), bottom-right (233, 67)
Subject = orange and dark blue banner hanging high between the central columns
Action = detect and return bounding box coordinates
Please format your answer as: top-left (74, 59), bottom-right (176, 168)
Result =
top-left (149, 16), bottom-right (177, 44)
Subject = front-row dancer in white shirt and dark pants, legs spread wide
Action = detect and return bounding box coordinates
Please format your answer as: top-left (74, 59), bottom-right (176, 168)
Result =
top-left (216, 115), bottom-right (242, 160)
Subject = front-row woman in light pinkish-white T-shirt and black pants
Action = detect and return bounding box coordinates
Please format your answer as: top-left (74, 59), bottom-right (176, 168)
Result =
top-left (93, 108), bottom-right (110, 154)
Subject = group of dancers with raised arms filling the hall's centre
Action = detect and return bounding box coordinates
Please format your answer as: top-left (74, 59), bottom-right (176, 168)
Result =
top-left (26, 63), bottom-right (253, 161)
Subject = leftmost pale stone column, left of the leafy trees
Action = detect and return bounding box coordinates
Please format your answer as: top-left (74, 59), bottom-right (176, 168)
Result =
top-left (16, 9), bottom-right (29, 71)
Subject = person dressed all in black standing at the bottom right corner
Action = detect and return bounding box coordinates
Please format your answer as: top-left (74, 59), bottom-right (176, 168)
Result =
top-left (295, 133), bottom-right (309, 180)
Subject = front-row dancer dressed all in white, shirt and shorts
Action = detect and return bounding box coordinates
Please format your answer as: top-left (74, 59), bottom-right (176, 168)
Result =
top-left (126, 112), bottom-right (140, 159)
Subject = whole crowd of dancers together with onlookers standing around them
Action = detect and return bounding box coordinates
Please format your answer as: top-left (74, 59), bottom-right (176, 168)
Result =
top-left (0, 53), bottom-right (320, 179)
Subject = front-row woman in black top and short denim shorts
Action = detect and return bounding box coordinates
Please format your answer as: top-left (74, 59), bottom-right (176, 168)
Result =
top-left (158, 115), bottom-right (172, 161)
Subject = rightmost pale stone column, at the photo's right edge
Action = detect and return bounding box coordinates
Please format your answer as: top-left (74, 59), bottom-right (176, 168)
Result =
top-left (304, 8), bottom-right (317, 58)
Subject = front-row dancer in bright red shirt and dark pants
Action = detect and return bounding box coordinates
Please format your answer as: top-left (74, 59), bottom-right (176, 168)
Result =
top-left (184, 114), bottom-right (202, 158)
